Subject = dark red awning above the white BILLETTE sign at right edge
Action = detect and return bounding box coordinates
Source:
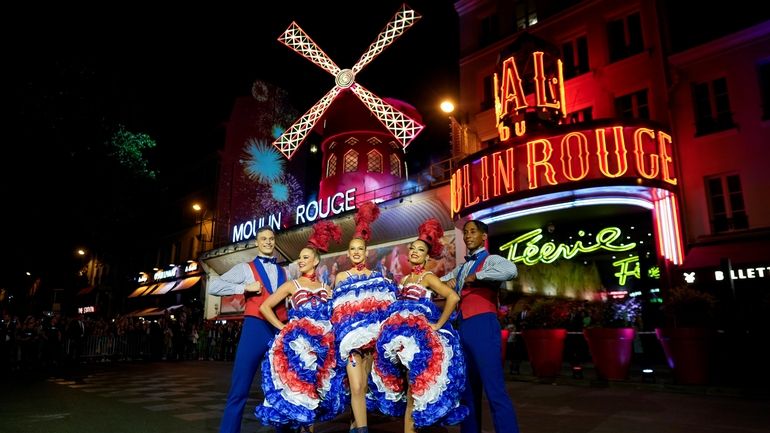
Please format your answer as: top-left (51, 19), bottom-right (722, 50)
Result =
top-left (682, 237), bottom-right (770, 269)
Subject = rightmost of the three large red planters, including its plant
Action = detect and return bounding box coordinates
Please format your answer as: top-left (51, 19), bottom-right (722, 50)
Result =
top-left (655, 286), bottom-right (716, 385)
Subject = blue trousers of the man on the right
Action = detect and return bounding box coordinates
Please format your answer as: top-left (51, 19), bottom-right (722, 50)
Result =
top-left (458, 313), bottom-right (519, 433)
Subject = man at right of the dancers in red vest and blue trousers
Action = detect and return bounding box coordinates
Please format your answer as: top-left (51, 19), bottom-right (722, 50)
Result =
top-left (441, 220), bottom-right (519, 433)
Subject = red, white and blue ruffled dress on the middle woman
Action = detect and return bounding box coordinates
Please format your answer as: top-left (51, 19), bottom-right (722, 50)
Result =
top-left (331, 271), bottom-right (398, 368)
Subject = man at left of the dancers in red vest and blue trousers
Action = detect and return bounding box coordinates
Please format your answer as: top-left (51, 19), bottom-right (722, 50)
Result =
top-left (208, 227), bottom-right (289, 433)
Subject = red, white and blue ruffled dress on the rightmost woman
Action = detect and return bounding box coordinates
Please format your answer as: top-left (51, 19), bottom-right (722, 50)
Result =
top-left (369, 273), bottom-right (468, 428)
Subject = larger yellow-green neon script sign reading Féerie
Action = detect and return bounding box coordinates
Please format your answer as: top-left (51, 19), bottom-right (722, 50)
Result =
top-left (500, 227), bottom-right (636, 266)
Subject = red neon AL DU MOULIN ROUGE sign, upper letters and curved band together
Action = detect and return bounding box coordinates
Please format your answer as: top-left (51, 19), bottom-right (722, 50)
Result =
top-left (451, 52), bottom-right (678, 214)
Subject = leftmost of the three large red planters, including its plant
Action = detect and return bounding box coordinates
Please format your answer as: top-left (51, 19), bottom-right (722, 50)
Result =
top-left (521, 298), bottom-right (570, 377)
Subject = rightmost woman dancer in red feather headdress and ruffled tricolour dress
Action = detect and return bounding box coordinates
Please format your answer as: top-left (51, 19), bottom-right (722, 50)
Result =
top-left (370, 218), bottom-right (468, 433)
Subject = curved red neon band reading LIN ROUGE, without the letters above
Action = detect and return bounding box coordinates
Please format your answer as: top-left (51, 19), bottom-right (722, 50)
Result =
top-left (451, 126), bottom-right (678, 214)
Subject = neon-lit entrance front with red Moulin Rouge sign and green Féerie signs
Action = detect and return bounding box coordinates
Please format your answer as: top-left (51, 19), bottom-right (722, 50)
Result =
top-left (451, 52), bottom-right (683, 322)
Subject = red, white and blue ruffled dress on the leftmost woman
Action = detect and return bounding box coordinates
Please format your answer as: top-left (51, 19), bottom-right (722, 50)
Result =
top-left (254, 280), bottom-right (345, 428)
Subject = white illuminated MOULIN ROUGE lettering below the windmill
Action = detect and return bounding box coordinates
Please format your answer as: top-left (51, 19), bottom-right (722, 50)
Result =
top-left (232, 188), bottom-right (356, 242)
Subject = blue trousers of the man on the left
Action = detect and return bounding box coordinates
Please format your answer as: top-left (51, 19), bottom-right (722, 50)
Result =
top-left (219, 316), bottom-right (278, 433)
